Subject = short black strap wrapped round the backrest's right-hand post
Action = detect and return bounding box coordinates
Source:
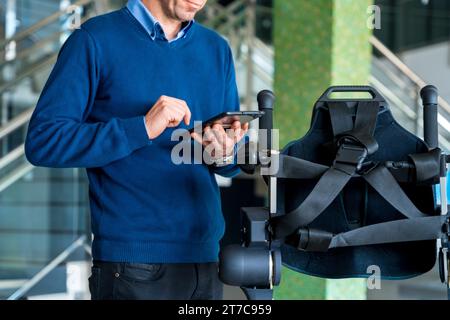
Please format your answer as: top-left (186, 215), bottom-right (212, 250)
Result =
top-left (409, 149), bottom-right (442, 182)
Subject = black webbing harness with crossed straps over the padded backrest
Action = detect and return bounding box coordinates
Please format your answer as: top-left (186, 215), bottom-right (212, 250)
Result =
top-left (271, 101), bottom-right (448, 252)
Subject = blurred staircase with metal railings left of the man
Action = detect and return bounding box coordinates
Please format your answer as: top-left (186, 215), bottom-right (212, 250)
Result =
top-left (0, 0), bottom-right (118, 299)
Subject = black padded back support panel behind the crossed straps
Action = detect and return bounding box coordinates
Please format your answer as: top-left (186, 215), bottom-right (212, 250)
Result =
top-left (277, 102), bottom-right (436, 279)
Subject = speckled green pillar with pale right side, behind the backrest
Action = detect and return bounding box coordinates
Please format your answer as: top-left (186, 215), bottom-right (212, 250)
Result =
top-left (274, 0), bottom-right (372, 299)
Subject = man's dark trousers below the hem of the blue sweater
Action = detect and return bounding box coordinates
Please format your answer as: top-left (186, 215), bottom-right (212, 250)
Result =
top-left (89, 261), bottom-right (223, 300)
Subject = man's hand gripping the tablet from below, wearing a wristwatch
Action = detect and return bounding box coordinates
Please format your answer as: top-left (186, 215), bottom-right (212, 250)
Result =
top-left (191, 121), bottom-right (249, 159)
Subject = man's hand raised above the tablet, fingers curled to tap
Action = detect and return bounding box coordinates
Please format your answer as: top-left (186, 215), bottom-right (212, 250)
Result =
top-left (145, 96), bottom-right (191, 139)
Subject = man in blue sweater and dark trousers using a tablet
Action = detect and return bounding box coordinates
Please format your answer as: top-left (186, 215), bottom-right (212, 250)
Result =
top-left (25, 0), bottom-right (248, 299)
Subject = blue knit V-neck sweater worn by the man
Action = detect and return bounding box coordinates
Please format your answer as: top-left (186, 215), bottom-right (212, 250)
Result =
top-left (25, 8), bottom-right (239, 263)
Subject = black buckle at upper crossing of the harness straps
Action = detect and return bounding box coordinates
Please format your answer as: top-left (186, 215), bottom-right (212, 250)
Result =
top-left (333, 137), bottom-right (368, 171)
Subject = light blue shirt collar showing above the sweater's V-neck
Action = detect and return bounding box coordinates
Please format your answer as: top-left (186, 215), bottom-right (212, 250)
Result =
top-left (127, 0), bottom-right (194, 42)
